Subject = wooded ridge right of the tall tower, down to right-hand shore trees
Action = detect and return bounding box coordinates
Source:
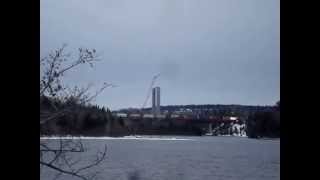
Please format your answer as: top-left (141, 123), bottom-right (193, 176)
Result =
top-left (140, 101), bottom-right (280, 138)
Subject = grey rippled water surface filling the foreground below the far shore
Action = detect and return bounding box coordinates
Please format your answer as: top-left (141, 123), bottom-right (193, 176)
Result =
top-left (41, 137), bottom-right (280, 180)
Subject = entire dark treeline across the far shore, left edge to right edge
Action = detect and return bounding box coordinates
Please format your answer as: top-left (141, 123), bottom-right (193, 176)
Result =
top-left (40, 96), bottom-right (280, 138)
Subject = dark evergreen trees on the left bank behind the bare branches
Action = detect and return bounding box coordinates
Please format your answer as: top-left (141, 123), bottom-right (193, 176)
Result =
top-left (40, 96), bottom-right (125, 136)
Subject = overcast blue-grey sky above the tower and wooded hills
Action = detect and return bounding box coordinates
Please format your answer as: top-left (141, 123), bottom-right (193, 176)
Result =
top-left (40, 0), bottom-right (280, 110)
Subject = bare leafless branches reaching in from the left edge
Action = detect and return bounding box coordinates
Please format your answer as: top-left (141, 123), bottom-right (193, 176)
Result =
top-left (40, 45), bottom-right (114, 180)
